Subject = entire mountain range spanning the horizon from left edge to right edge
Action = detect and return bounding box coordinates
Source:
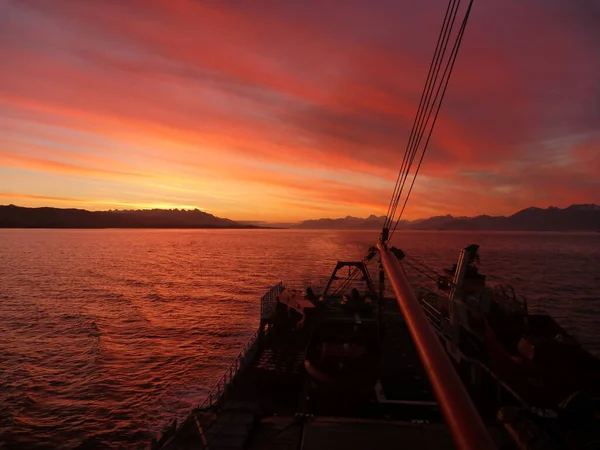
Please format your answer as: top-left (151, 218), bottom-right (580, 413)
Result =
top-left (0, 203), bottom-right (600, 231)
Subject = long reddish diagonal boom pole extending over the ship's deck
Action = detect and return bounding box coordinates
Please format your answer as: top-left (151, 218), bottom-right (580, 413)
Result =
top-left (377, 242), bottom-right (495, 450)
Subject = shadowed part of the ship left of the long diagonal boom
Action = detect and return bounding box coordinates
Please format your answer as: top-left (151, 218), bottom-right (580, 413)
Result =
top-left (153, 262), bottom-right (460, 449)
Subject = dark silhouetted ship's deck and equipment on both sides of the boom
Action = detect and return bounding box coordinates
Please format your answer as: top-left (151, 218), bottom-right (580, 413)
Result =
top-left (151, 251), bottom-right (600, 450)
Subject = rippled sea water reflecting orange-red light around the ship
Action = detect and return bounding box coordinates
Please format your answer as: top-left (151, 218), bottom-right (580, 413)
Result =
top-left (0, 230), bottom-right (600, 449)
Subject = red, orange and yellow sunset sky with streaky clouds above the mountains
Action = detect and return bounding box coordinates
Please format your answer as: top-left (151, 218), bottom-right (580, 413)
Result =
top-left (0, 0), bottom-right (600, 220)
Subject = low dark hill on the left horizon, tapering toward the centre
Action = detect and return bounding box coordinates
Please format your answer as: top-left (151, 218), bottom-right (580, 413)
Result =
top-left (0, 205), bottom-right (257, 228)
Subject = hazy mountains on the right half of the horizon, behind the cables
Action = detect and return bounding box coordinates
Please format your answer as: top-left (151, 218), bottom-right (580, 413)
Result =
top-left (293, 203), bottom-right (600, 231)
